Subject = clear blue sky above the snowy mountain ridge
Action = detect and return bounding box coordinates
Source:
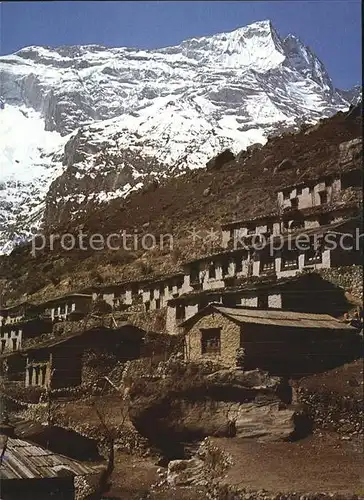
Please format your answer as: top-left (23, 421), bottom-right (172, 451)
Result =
top-left (0, 0), bottom-right (361, 88)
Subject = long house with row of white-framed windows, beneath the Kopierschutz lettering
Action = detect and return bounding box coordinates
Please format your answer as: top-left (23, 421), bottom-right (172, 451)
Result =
top-left (180, 208), bottom-right (361, 304)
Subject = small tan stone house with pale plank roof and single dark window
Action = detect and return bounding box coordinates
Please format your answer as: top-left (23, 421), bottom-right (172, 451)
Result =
top-left (181, 304), bottom-right (360, 376)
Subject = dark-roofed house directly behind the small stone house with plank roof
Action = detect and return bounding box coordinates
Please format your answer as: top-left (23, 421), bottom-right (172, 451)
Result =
top-left (166, 272), bottom-right (348, 334)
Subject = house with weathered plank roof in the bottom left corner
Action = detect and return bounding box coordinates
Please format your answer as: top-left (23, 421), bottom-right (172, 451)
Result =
top-left (0, 423), bottom-right (99, 500)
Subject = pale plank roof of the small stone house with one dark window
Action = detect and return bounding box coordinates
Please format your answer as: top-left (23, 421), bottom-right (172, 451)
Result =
top-left (180, 304), bottom-right (355, 332)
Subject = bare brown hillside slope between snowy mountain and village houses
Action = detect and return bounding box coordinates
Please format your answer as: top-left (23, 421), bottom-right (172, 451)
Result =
top-left (0, 103), bottom-right (362, 300)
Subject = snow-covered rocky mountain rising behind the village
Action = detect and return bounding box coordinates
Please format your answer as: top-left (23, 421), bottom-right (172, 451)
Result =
top-left (0, 21), bottom-right (358, 251)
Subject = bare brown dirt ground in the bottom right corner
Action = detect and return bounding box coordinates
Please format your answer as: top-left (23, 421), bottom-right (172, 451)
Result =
top-left (215, 434), bottom-right (364, 494)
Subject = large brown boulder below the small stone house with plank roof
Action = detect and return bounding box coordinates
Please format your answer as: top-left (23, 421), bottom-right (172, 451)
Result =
top-left (130, 370), bottom-right (309, 456)
